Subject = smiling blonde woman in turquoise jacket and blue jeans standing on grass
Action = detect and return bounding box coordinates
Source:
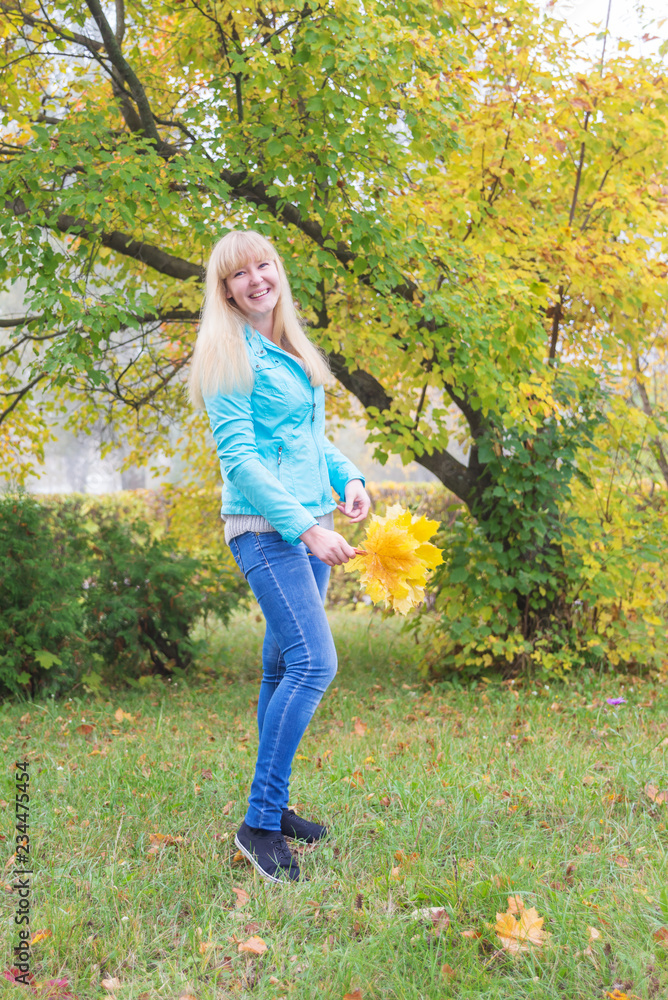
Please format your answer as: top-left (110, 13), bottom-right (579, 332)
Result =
top-left (190, 231), bottom-right (370, 882)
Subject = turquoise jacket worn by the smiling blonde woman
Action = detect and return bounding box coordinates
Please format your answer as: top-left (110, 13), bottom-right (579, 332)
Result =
top-left (204, 328), bottom-right (365, 545)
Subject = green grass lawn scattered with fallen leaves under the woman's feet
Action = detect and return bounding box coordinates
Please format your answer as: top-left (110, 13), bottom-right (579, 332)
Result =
top-left (0, 611), bottom-right (668, 1000)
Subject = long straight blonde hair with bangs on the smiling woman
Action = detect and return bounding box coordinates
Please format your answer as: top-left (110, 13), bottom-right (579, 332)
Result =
top-left (188, 229), bottom-right (330, 409)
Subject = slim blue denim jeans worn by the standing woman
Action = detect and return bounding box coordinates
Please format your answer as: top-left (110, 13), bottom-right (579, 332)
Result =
top-left (230, 531), bottom-right (337, 830)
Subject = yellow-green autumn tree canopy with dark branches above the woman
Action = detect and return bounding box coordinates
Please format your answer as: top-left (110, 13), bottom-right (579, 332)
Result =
top-left (0, 0), bottom-right (668, 672)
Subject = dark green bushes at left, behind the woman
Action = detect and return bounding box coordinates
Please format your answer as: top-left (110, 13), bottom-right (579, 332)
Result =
top-left (0, 494), bottom-right (245, 695)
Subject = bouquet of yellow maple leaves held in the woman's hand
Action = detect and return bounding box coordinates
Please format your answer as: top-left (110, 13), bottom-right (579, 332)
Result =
top-left (344, 504), bottom-right (443, 615)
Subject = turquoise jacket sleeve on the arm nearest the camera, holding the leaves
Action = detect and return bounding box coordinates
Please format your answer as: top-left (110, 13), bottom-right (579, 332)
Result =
top-left (204, 393), bottom-right (318, 545)
